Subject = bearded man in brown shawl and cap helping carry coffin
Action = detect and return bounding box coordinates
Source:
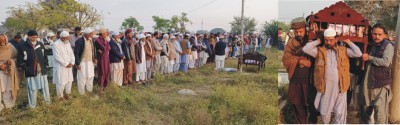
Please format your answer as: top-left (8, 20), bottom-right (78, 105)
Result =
top-left (282, 21), bottom-right (311, 124)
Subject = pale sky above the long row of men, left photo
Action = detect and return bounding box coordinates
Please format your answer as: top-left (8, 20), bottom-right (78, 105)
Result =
top-left (0, 0), bottom-right (278, 31)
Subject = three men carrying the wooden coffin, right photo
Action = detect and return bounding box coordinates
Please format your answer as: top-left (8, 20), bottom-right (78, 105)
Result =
top-left (282, 21), bottom-right (394, 124)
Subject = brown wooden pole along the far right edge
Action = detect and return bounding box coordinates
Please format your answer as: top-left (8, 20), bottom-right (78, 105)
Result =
top-left (389, 2), bottom-right (400, 123)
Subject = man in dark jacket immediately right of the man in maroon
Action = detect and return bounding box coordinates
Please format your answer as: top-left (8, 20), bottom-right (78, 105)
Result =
top-left (110, 32), bottom-right (125, 86)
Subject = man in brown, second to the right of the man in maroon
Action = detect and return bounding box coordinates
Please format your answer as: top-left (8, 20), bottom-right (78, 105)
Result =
top-left (121, 29), bottom-right (136, 85)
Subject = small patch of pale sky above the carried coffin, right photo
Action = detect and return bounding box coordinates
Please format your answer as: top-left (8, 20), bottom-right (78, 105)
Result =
top-left (278, 0), bottom-right (339, 22)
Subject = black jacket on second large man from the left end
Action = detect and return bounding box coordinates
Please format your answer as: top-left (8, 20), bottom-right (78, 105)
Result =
top-left (17, 40), bottom-right (49, 77)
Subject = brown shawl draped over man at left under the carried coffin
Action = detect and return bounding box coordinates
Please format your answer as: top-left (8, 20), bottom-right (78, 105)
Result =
top-left (282, 37), bottom-right (304, 80)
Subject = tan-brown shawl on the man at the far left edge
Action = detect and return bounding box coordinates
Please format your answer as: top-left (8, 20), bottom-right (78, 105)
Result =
top-left (0, 34), bottom-right (20, 99)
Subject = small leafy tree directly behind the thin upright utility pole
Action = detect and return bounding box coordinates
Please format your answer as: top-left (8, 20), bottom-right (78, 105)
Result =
top-left (230, 16), bottom-right (257, 34)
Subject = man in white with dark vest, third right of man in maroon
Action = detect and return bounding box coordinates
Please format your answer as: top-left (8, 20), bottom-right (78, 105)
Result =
top-left (135, 34), bottom-right (147, 84)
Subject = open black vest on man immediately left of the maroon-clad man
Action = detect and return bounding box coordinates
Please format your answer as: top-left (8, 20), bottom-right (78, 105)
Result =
top-left (74, 37), bottom-right (96, 66)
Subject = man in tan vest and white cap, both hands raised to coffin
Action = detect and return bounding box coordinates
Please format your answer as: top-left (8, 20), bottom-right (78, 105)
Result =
top-left (302, 29), bottom-right (362, 124)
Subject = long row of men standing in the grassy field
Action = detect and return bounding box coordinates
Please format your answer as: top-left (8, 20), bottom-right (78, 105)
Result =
top-left (0, 27), bottom-right (272, 111)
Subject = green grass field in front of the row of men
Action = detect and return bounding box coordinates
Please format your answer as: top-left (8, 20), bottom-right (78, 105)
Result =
top-left (0, 49), bottom-right (281, 125)
